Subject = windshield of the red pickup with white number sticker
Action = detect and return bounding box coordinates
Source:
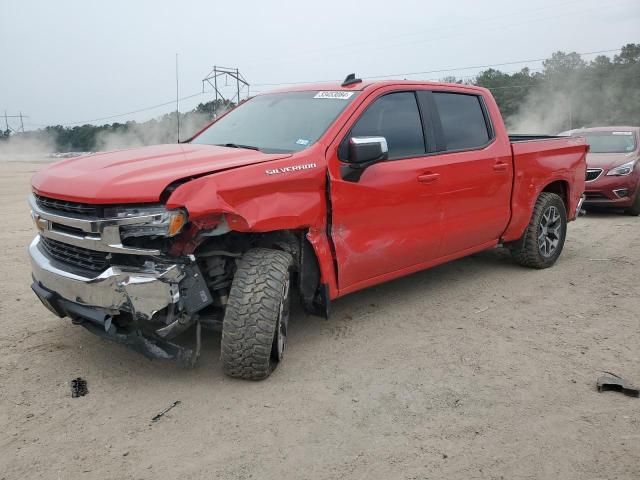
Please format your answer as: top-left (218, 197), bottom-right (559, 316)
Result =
top-left (192, 91), bottom-right (357, 153)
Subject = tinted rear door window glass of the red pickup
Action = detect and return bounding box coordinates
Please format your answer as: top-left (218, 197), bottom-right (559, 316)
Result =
top-left (433, 92), bottom-right (490, 150)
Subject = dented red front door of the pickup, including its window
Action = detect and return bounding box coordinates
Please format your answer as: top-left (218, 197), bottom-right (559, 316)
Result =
top-left (328, 88), bottom-right (442, 293)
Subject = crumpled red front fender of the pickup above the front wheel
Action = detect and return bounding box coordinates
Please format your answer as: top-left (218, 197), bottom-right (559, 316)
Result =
top-left (167, 160), bottom-right (337, 304)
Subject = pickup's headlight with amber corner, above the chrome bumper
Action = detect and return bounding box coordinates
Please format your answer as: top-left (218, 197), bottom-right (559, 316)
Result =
top-left (104, 206), bottom-right (187, 239)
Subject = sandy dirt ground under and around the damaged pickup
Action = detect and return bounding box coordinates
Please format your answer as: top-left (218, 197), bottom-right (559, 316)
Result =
top-left (0, 162), bottom-right (640, 480)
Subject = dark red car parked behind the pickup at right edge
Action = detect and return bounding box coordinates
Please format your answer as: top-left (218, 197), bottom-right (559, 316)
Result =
top-left (560, 127), bottom-right (640, 216)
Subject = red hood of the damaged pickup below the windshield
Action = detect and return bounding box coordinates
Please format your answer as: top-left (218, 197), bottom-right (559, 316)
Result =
top-left (31, 144), bottom-right (291, 204)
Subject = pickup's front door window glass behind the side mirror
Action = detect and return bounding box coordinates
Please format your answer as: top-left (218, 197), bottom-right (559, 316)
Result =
top-left (351, 92), bottom-right (425, 159)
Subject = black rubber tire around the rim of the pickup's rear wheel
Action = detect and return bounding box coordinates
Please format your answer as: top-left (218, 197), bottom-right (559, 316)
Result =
top-left (509, 192), bottom-right (567, 269)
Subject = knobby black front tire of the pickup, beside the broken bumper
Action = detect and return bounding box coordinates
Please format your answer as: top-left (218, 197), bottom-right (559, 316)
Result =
top-left (221, 248), bottom-right (293, 380)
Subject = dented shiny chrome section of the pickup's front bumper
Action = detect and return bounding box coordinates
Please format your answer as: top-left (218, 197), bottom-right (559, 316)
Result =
top-left (29, 236), bottom-right (186, 320)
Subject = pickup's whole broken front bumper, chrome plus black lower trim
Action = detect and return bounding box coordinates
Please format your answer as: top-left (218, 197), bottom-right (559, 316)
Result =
top-left (29, 236), bottom-right (212, 365)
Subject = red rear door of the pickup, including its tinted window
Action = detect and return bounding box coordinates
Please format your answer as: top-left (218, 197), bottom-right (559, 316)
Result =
top-left (423, 91), bottom-right (513, 256)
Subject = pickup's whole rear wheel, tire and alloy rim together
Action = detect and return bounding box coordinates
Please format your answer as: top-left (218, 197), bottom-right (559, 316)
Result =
top-left (509, 192), bottom-right (567, 269)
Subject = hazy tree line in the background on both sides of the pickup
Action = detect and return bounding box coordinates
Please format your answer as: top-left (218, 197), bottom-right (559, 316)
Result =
top-left (0, 43), bottom-right (640, 152)
